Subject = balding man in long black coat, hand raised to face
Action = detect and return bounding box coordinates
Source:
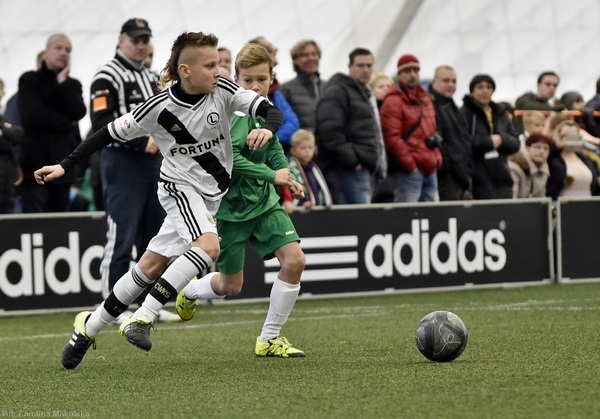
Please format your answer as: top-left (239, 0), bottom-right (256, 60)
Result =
top-left (19, 34), bottom-right (86, 213)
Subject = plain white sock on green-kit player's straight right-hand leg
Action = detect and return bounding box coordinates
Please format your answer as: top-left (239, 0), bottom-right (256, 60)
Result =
top-left (260, 278), bottom-right (300, 342)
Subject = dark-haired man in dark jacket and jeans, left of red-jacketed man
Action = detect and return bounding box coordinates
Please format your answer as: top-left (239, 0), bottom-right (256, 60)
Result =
top-left (316, 48), bottom-right (385, 204)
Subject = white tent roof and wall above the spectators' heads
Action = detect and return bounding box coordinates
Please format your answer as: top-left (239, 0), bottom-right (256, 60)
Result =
top-left (0, 0), bottom-right (600, 132)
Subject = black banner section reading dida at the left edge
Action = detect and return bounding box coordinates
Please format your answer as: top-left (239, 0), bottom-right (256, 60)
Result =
top-left (0, 212), bottom-right (106, 313)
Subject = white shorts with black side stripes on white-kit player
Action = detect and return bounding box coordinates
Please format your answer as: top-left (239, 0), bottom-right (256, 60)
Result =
top-left (148, 181), bottom-right (221, 258)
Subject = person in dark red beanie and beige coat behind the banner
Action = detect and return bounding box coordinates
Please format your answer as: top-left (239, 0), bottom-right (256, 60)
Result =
top-left (508, 132), bottom-right (552, 198)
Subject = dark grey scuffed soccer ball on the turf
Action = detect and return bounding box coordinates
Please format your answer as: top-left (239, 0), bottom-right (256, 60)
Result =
top-left (415, 310), bottom-right (467, 362)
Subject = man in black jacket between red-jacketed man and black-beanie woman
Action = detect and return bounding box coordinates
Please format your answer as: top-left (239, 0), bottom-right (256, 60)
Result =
top-left (429, 65), bottom-right (473, 201)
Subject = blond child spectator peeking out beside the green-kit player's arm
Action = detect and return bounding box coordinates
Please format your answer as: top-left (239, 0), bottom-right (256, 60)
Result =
top-left (281, 129), bottom-right (331, 214)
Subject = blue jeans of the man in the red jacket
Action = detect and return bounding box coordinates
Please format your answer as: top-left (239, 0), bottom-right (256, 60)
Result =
top-left (394, 170), bottom-right (440, 202)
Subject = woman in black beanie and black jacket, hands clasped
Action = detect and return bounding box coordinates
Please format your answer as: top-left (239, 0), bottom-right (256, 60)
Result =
top-left (460, 74), bottom-right (520, 199)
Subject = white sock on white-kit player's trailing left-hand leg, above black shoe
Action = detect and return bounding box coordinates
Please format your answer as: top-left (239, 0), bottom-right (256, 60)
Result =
top-left (85, 263), bottom-right (152, 336)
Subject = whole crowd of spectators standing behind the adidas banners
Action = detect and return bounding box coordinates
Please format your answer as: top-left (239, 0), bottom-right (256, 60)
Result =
top-left (0, 18), bottom-right (600, 220)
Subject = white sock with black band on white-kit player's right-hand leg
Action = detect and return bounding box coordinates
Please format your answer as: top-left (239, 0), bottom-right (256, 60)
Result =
top-left (133, 247), bottom-right (213, 323)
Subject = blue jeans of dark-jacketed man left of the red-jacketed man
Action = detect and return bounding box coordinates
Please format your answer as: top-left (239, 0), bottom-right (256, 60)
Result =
top-left (325, 167), bottom-right (373, 205)
